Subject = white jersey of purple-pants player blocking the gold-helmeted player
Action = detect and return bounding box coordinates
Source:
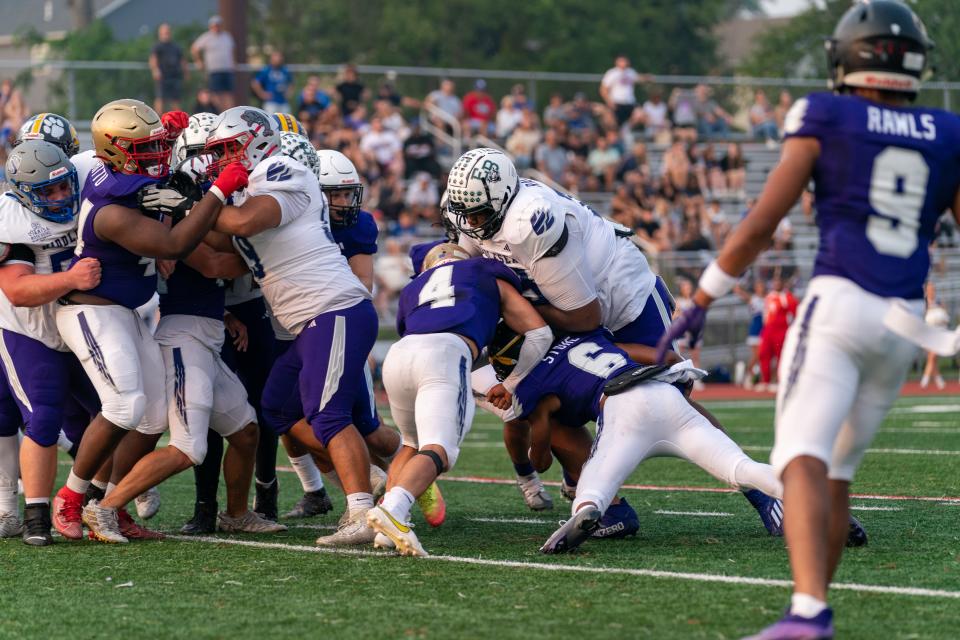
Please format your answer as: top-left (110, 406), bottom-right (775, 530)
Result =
top-left (233, 156), bottom-right (370, 335)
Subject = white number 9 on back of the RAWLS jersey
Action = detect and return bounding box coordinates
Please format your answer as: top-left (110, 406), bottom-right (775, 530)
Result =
top-left (867, 147), bottom-right (930, 258)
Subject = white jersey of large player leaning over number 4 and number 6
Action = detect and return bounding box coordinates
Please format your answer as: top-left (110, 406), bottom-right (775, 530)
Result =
top-left (460, 178), bottom-right (656, 331)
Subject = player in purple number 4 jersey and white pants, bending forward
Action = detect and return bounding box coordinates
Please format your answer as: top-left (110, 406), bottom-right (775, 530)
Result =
top-left (367, 244), bottom-right (553, 556)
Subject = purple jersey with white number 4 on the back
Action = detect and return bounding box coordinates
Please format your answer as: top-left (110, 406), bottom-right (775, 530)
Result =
top-left (397, 258), bottom-right (520, 349)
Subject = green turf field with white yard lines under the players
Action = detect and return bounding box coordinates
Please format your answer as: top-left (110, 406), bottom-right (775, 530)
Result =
top-left (0, 397), bottom-right (960, 640)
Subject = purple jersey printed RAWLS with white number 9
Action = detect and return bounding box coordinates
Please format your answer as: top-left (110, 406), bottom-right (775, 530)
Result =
top-left (784, 93), bottom-right (960, 298)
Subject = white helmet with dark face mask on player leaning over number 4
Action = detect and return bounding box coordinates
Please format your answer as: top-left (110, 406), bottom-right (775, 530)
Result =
top-left (447, 148), bottom-right (520, 240)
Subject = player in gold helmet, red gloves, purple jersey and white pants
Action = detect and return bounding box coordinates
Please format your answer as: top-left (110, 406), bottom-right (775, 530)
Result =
top-left (53, 99), bottom-right (221, 539)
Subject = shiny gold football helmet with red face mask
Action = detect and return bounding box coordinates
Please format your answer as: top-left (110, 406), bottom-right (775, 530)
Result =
top-left (90, 99), bottom-right (170, 178)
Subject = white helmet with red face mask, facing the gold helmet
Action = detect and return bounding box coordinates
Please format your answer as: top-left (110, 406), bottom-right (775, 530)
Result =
top-left (204, 107), bottom-right (280, 177)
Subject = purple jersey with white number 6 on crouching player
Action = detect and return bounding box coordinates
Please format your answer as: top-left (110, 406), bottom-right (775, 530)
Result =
top-left (513, 329), bottom-right (637, 427)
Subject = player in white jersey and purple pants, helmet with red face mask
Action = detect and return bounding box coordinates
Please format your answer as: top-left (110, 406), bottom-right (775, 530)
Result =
top-left (196, 107), bottom-right (378, 545)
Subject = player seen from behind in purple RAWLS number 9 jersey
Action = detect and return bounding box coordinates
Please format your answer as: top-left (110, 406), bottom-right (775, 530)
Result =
top-left (661, 0), bottom-right (960, 640)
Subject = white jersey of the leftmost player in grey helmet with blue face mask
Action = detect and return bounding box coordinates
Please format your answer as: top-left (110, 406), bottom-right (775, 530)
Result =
top-left (0, 194), bottom-right (77, 351)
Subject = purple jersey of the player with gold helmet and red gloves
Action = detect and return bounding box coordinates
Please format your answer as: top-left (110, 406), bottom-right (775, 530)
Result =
top-left (73, 163), bottom-right (158, 309)
